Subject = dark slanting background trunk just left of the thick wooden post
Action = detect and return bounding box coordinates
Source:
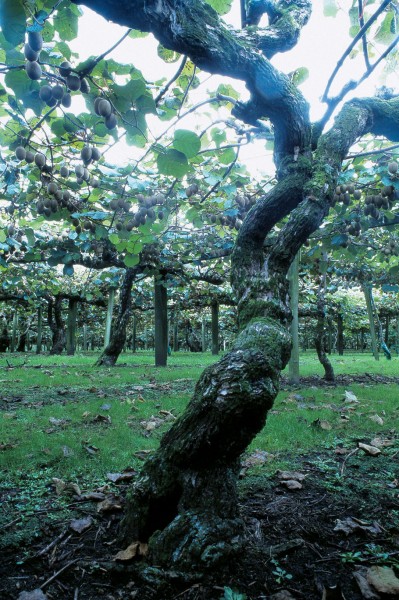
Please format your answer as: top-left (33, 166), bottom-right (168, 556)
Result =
top-left (96, 268), bottom-right (136, 367)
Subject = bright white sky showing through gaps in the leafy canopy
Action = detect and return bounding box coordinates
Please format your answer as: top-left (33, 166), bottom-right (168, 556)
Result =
top-left (71, 0), bottom-right (399, 176)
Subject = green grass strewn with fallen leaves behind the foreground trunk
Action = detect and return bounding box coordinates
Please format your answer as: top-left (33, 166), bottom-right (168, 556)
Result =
top-left (0, 351), bottom-right (399, 544)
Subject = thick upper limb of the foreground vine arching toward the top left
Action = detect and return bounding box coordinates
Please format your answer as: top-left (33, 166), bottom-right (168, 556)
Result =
top-left (73, 0), bottom-right (310, 160)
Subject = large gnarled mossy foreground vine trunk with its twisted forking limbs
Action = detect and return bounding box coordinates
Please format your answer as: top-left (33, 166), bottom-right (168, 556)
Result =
top-left (76, 0), bottom-right (399, 578)
